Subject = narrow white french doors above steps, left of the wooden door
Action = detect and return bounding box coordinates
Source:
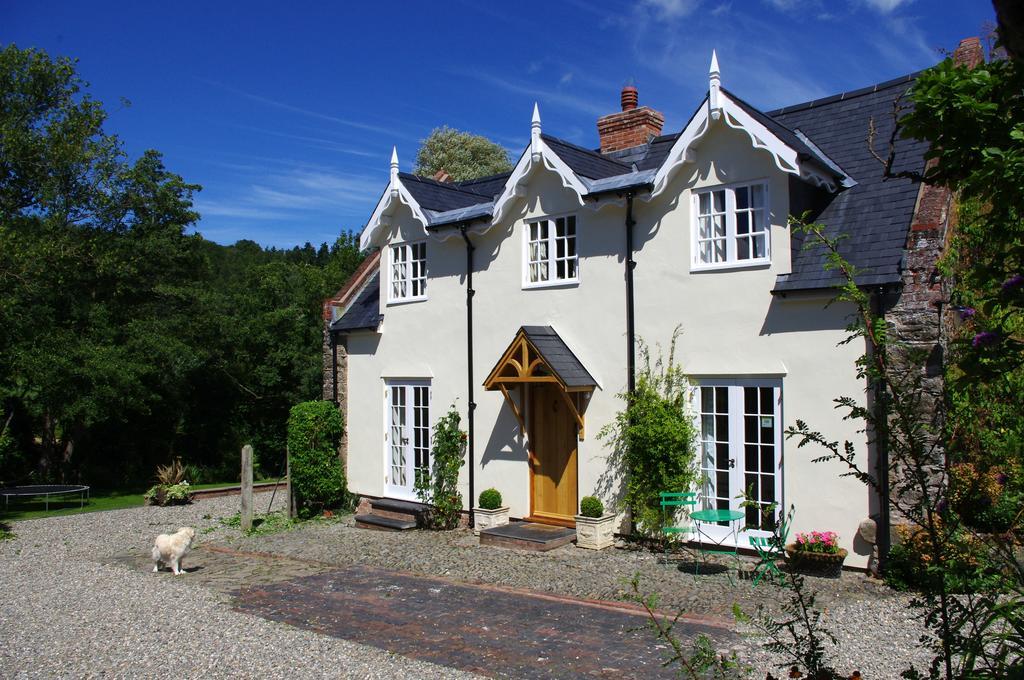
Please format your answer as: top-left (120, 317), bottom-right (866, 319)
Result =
top-left (384, 380), bottom-right (430, 501)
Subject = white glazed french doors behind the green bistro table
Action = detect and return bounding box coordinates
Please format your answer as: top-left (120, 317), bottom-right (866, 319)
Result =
top-left (695, 380), bottom-right (783, 548)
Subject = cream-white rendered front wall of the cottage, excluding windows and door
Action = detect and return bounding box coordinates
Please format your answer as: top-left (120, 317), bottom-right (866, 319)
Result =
top-left (346, 125), bottom-right (871, 566)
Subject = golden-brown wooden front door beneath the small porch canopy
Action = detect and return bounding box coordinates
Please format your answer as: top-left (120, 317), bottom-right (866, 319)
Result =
top-left (529, 384), bottom-right (579, 524)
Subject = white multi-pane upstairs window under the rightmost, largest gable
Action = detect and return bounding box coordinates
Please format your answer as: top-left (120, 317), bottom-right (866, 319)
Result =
top-left (694, 184), bottom-right (770, 266)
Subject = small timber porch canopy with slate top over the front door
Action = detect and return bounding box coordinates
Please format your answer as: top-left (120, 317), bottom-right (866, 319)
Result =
top-left (483, 326), bottom-right (597, 439)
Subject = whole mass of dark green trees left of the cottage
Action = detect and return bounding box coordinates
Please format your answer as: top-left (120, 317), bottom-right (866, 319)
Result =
top-left (0, 45), bottom-right (359, 485)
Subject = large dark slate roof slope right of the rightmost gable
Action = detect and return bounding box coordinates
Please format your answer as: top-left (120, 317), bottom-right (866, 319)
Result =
top-left (766, 74), bottom-right (928, 292)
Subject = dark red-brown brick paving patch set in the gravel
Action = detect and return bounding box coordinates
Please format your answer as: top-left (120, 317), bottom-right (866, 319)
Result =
top-left (234, 565), bottom-right (736, 678)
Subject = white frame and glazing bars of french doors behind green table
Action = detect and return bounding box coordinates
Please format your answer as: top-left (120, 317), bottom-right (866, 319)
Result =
top-left (691, 377), bottom-right (785, 548)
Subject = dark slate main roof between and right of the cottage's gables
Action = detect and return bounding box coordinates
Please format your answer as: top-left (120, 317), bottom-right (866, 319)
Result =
top-left (374, 74), bottom-right (927, 292)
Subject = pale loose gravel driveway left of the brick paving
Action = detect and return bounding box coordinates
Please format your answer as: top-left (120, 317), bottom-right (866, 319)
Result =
top-left (0, 495), bottom-right (476, 678)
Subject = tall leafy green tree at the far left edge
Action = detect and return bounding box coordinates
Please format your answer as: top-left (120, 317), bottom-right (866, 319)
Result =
top-left (0, 45), bottom-right (201, 477)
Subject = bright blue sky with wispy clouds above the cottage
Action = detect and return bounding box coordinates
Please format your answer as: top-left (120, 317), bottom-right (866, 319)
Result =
top-left (0, 0), bottom-right (993, 247)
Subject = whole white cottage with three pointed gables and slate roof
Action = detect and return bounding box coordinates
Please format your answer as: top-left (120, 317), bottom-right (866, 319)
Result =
top-left (325, 49), bottom-right (949, 566)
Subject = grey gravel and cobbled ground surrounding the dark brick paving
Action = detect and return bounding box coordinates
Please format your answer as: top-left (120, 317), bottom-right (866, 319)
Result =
top-left (0, 495), bottom-right (928, 679)
